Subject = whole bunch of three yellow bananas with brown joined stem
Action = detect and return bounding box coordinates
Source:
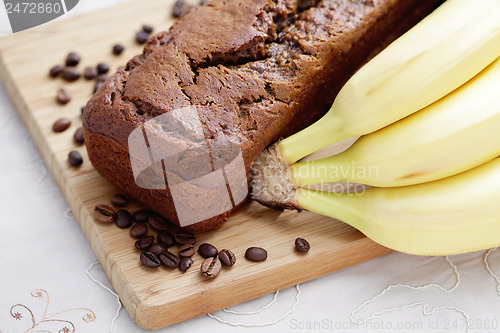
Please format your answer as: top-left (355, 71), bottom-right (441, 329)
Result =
top-left (252, 0), bottom-right (500, 255)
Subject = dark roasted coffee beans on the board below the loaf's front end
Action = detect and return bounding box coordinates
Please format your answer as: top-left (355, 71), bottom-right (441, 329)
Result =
top-left (94, 194), bottom-right (311, 279)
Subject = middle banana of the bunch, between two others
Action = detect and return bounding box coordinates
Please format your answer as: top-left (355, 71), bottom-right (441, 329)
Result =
top-left (290, 56), bottom-right (500, 187)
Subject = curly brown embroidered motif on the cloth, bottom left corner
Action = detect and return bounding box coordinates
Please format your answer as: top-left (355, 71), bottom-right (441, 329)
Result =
top-left (0, 289), bottom-right (96, 333)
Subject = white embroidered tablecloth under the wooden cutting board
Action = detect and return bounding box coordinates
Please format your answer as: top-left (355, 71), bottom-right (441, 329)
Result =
top-left (0, 0), bottom-right (500, 333)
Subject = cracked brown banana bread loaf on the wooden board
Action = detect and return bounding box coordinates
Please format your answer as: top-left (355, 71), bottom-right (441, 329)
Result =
top-left (83, 0), bottom-right (442, 232)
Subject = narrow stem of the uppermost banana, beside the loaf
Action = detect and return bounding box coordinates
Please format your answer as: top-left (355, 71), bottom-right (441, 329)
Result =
top-left (278, 113), bottom-right (348, 164)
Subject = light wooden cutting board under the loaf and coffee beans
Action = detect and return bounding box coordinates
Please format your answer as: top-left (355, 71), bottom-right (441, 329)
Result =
top-left (0, 0), bottom-right (390, 329)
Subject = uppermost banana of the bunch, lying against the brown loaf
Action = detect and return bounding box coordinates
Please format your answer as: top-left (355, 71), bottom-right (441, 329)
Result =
top-left (278, 0), bottom-right (500, 164)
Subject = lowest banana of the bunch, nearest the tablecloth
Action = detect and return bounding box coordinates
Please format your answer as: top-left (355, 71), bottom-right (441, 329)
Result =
top-left (296, 158), bottom-right (500, 255)
